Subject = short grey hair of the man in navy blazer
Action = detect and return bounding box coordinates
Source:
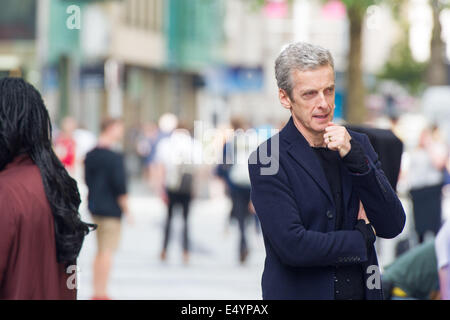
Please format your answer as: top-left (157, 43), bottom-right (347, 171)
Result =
top-left (275, 42), bottom-right (334, 99)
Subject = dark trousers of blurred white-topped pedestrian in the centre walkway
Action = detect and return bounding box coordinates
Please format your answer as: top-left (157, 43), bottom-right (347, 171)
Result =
top-left (163, 191), bottom-right (192, 251)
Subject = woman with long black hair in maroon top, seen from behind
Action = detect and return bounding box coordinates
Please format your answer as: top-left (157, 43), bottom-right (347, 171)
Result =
top-left (0, 78), bottom-right (95, 300)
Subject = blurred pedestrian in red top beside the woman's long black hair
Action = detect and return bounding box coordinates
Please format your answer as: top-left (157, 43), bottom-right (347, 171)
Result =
top-left (54, 117), bottom-right (78, 175)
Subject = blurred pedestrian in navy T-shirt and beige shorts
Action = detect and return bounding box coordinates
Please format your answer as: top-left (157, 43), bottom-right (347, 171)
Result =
top-left (85, 119), bottom-right (132, 300)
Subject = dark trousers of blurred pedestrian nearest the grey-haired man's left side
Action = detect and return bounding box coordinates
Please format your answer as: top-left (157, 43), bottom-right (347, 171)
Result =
top-left (230, 188), bottom-right (250, 254)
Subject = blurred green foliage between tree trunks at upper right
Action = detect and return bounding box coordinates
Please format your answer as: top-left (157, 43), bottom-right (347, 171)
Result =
top-left (377, 37), bottom-right (427, 95)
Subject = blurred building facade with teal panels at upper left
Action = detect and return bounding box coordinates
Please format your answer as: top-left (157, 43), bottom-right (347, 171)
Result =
top-left (27, 0), bottom-right (223, 132)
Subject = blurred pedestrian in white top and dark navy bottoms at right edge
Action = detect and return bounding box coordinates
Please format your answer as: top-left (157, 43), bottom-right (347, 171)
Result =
top-left (408, 128), bottom-right (447, 242)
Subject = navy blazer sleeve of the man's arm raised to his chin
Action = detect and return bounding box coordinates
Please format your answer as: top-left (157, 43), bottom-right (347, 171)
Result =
top-left (350, 135), bottom-right (406, 239)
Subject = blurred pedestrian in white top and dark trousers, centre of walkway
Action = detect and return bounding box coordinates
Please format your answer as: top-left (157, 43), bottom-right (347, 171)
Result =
top-left (155, 123), bottom-right (201, 264)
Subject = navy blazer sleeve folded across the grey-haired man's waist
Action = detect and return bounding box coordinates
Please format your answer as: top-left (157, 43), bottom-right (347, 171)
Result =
top-left (249, 154), bottom-right (367, 267)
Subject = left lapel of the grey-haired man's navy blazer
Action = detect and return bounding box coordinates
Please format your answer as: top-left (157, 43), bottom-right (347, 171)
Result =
top-left (281, 117), bottom-right (334, 203)
